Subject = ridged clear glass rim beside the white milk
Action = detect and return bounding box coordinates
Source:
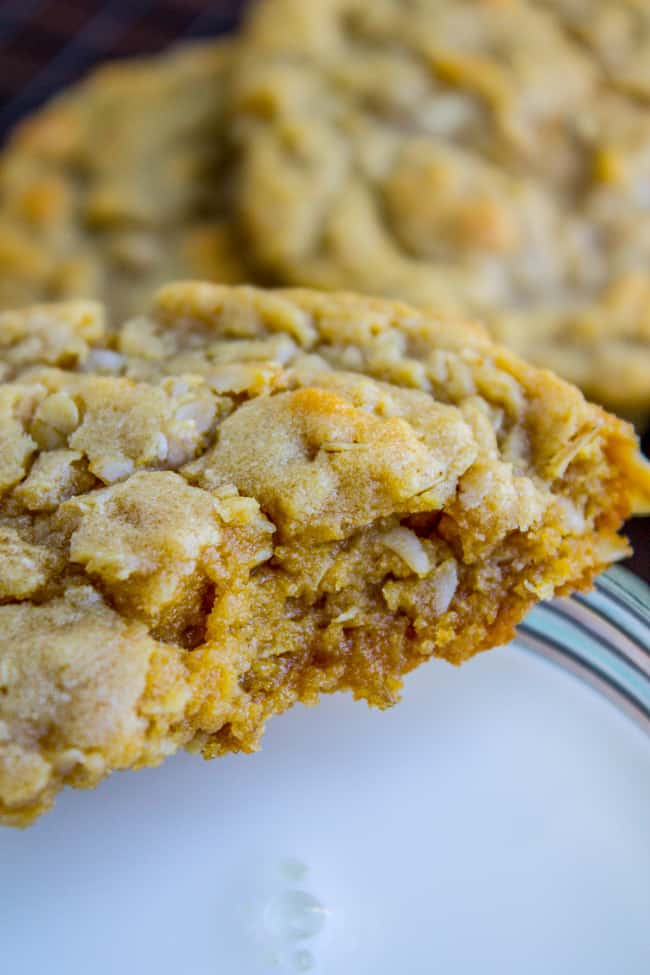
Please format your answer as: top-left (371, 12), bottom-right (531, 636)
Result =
top-left (516, 566), bottom-right (650, 734)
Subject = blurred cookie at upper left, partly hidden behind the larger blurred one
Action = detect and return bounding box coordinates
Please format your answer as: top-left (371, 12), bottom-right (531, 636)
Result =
top-left (0, 43), bottom-right (246, 322)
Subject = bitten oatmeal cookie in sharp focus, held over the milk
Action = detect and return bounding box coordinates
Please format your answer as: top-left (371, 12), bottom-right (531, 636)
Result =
top-left (0, 284), bottom-right (650, 825)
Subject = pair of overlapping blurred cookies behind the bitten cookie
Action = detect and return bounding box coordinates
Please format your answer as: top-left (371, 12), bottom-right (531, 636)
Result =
top-left (0, 0), bottom-right (650, 421)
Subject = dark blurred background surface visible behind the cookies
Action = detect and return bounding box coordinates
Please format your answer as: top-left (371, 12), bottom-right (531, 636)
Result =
top-left (0, 0), bottom-right (650, 582)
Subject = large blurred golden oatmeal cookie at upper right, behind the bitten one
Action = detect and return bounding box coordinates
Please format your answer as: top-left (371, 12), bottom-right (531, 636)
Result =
top-left (232, 0), bottom-right (650, 418)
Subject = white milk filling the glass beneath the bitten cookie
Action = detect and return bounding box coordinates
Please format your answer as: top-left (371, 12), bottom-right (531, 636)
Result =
top-left (0, 649), bottom-right (650, 975)
